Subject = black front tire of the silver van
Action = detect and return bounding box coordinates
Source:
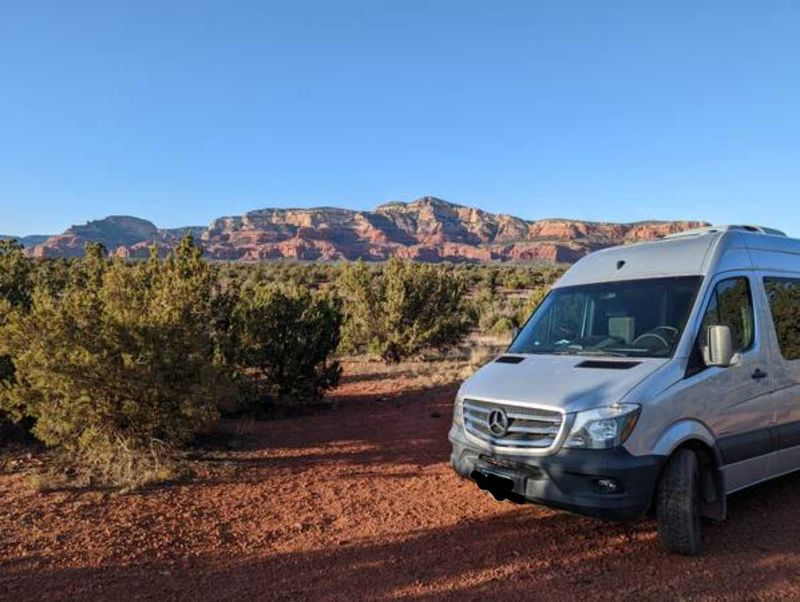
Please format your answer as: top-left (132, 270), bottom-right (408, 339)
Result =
top-left (656, 449), bottom-right (703, 556)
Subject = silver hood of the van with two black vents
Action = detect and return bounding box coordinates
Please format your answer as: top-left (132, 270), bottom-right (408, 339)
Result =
top-left (459, 354), bottom-right (669, 412)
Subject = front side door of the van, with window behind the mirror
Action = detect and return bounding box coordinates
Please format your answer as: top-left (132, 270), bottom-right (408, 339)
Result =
top-left (685, 272), bottom-right (774, 492)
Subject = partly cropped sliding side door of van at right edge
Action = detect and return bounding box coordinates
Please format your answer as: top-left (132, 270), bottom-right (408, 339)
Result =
top-left (762, 273), bottom-right (800, 477)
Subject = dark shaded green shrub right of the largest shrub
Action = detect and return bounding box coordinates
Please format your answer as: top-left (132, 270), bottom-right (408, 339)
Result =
top-left (232, 284), bottom-right (342, 410)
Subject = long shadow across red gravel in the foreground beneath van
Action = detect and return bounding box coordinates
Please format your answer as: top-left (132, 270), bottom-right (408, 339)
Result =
top-left (0, 477), bottom-right (800, 600)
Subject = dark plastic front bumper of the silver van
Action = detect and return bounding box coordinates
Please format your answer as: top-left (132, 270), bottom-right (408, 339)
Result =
top-left (450, 427), bottom-right (666, 521)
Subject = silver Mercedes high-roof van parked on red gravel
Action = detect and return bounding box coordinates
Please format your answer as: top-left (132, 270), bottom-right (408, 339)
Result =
top-left (449, 226), bottom-right (800, 554)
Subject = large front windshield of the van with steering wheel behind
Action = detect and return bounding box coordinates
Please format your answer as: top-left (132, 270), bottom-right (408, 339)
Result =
top-left (509, 276), bottom-right (702, 357)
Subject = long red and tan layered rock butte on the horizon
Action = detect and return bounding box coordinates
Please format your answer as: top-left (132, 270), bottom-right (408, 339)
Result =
top-left (29, 197), bottom-right (706, 263)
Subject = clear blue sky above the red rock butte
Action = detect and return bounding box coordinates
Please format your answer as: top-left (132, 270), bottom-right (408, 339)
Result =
top-left (0, 0), bottom-right (800, 235)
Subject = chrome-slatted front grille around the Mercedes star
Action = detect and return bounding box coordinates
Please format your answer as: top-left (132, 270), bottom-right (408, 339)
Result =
top-left (464, 399), bottom-right (563, 450)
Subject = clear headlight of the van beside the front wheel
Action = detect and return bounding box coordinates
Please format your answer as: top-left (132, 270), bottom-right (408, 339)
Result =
top-left (564, 403), bottom-right (642, 449)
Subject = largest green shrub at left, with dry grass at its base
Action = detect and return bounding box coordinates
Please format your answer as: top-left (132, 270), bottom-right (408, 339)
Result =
top-left (0, 238), bottom-right (225, 480)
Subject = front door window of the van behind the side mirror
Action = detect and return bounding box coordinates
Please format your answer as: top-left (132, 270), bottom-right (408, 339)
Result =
top-left (699, 277), bottom-right (755, 352)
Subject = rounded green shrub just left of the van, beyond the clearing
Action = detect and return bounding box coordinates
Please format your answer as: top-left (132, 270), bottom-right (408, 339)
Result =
top-left (338, 259), bottom-right (474, 363)
